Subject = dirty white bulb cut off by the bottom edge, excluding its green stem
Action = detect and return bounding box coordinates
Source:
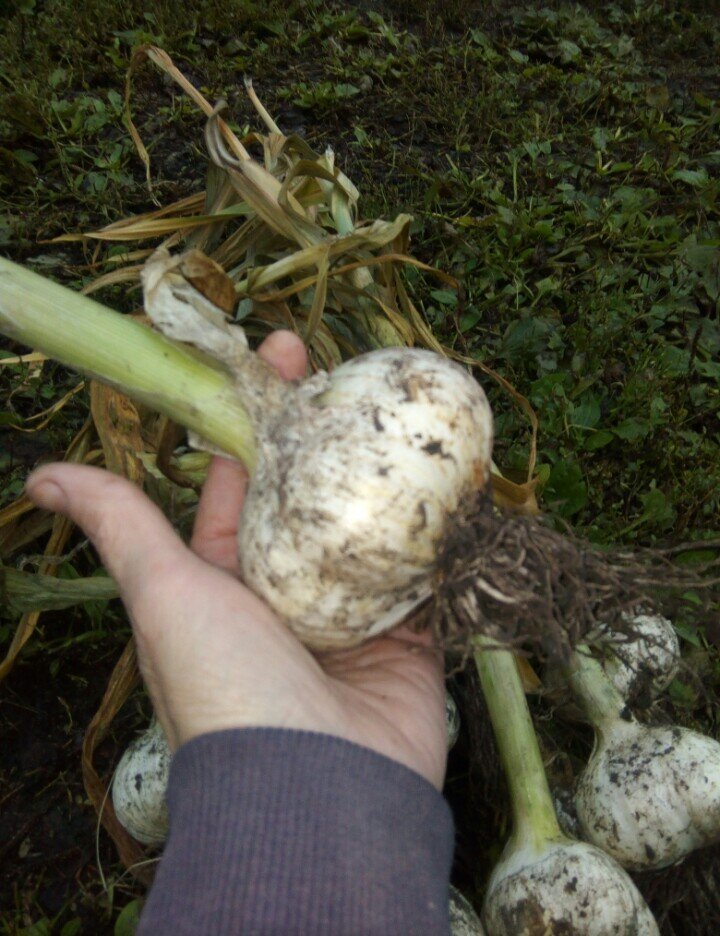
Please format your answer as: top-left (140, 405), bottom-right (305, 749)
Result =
top-left (482, 839), bottom-right (659, 936)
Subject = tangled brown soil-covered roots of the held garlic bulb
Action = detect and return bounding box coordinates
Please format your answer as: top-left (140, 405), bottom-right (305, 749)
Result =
top-left (432, 493), bottom-right (718, 661)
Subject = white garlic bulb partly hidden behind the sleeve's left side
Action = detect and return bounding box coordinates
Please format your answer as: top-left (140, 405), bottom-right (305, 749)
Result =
top-left (112, 721), bottom-right (172, 846)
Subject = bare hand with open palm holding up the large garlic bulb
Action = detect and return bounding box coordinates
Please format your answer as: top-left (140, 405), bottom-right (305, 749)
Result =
top-left (27, 332), bottom-right (446, 789)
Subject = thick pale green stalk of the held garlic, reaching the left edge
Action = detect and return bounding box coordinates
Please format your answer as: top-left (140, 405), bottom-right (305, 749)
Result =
top-left (0, 257), bottom-right (255, 468)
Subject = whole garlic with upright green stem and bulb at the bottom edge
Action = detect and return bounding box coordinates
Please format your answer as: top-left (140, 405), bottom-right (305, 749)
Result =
top-left (475, 638), bottom-right (659, 936)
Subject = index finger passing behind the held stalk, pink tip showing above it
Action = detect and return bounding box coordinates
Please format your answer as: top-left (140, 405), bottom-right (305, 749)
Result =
top-left (190, 331), bottom-right (307, 573)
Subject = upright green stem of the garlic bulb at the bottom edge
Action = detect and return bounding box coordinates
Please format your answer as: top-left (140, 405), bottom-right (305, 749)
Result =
top-left (474, 637), bottom-right (563, 850)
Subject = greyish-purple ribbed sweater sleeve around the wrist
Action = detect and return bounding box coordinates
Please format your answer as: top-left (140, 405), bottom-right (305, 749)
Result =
top-left (138, 728), bottom-right (453, 936)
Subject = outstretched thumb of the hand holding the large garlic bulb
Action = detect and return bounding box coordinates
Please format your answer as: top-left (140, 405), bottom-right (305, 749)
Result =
top-left (25, 463), bottom-right (192, 604)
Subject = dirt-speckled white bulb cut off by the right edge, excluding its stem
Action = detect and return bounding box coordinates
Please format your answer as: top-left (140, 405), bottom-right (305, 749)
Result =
top-left (575, 720), bottom-right (720, 871)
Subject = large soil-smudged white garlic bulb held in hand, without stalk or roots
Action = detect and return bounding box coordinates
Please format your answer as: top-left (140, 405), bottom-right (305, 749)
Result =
top-left (238, 348), bottom-right (492, 650)
